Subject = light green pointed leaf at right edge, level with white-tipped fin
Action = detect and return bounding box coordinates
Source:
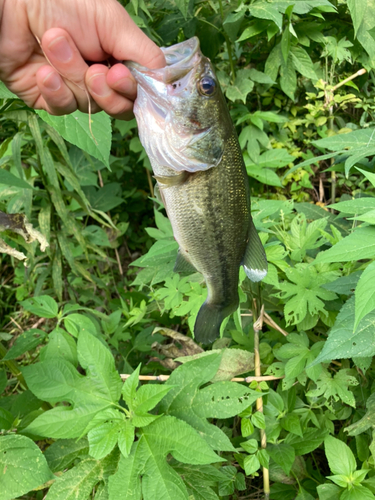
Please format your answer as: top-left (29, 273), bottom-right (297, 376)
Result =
top-left (314, 227), bottom-right (375, 264)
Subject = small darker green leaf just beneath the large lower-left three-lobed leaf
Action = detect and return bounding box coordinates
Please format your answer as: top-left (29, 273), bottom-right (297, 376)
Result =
top-left (44, 438), bottom-right (89, 472)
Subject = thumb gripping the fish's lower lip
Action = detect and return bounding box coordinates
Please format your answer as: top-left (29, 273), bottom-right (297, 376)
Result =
top-left (96, 1), bottom-right (165, 69)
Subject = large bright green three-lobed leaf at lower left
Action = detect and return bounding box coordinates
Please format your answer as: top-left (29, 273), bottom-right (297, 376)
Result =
top-left (23, 332), bottom-right (121, 438)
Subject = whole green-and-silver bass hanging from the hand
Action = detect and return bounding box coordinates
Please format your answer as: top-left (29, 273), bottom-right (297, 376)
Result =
top-left (126, 37), bottom-right (267, 344)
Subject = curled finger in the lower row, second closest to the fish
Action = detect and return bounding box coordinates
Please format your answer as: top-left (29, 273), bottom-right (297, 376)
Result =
top-left (86, 64), bottom-right (134, 120)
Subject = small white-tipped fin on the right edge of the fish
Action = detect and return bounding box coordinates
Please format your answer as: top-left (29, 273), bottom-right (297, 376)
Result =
top-left (242, 220), bottom-right (268, 282)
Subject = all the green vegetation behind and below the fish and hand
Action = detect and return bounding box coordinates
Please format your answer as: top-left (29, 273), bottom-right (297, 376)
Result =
top-left (0, 0), bottom-right (375, 500)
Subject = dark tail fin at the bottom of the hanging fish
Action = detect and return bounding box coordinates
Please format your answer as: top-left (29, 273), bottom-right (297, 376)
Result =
top-left (194, 300), bottom-right (238, 344)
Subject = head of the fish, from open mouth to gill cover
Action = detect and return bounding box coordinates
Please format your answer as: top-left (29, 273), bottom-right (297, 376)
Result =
top-left (126, 37), bottom-right (233, 172)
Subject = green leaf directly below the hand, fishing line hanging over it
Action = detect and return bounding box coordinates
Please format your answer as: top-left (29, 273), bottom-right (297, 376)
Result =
top-left (37, 111), bottom-right (112, 167)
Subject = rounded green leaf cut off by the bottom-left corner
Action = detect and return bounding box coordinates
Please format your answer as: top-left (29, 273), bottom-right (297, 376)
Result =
top-left (0, 434), bottom-right (55, 500)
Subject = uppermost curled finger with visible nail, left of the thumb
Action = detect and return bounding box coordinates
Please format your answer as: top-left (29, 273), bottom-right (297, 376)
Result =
top-left (42, 28), bottom-right (98, 112)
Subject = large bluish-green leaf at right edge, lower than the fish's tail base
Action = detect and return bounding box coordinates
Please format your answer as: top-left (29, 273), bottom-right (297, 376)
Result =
top-left (311, 296), bottom-right (375, 365)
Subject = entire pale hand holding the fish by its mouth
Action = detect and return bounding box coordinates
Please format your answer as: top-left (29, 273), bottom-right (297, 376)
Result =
top-left (0, 0), bottom-right (165, 119)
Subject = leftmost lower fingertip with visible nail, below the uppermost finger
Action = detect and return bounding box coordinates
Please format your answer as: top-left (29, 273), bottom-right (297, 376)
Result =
top-left (36, 65), bottom-right (77, 116)
